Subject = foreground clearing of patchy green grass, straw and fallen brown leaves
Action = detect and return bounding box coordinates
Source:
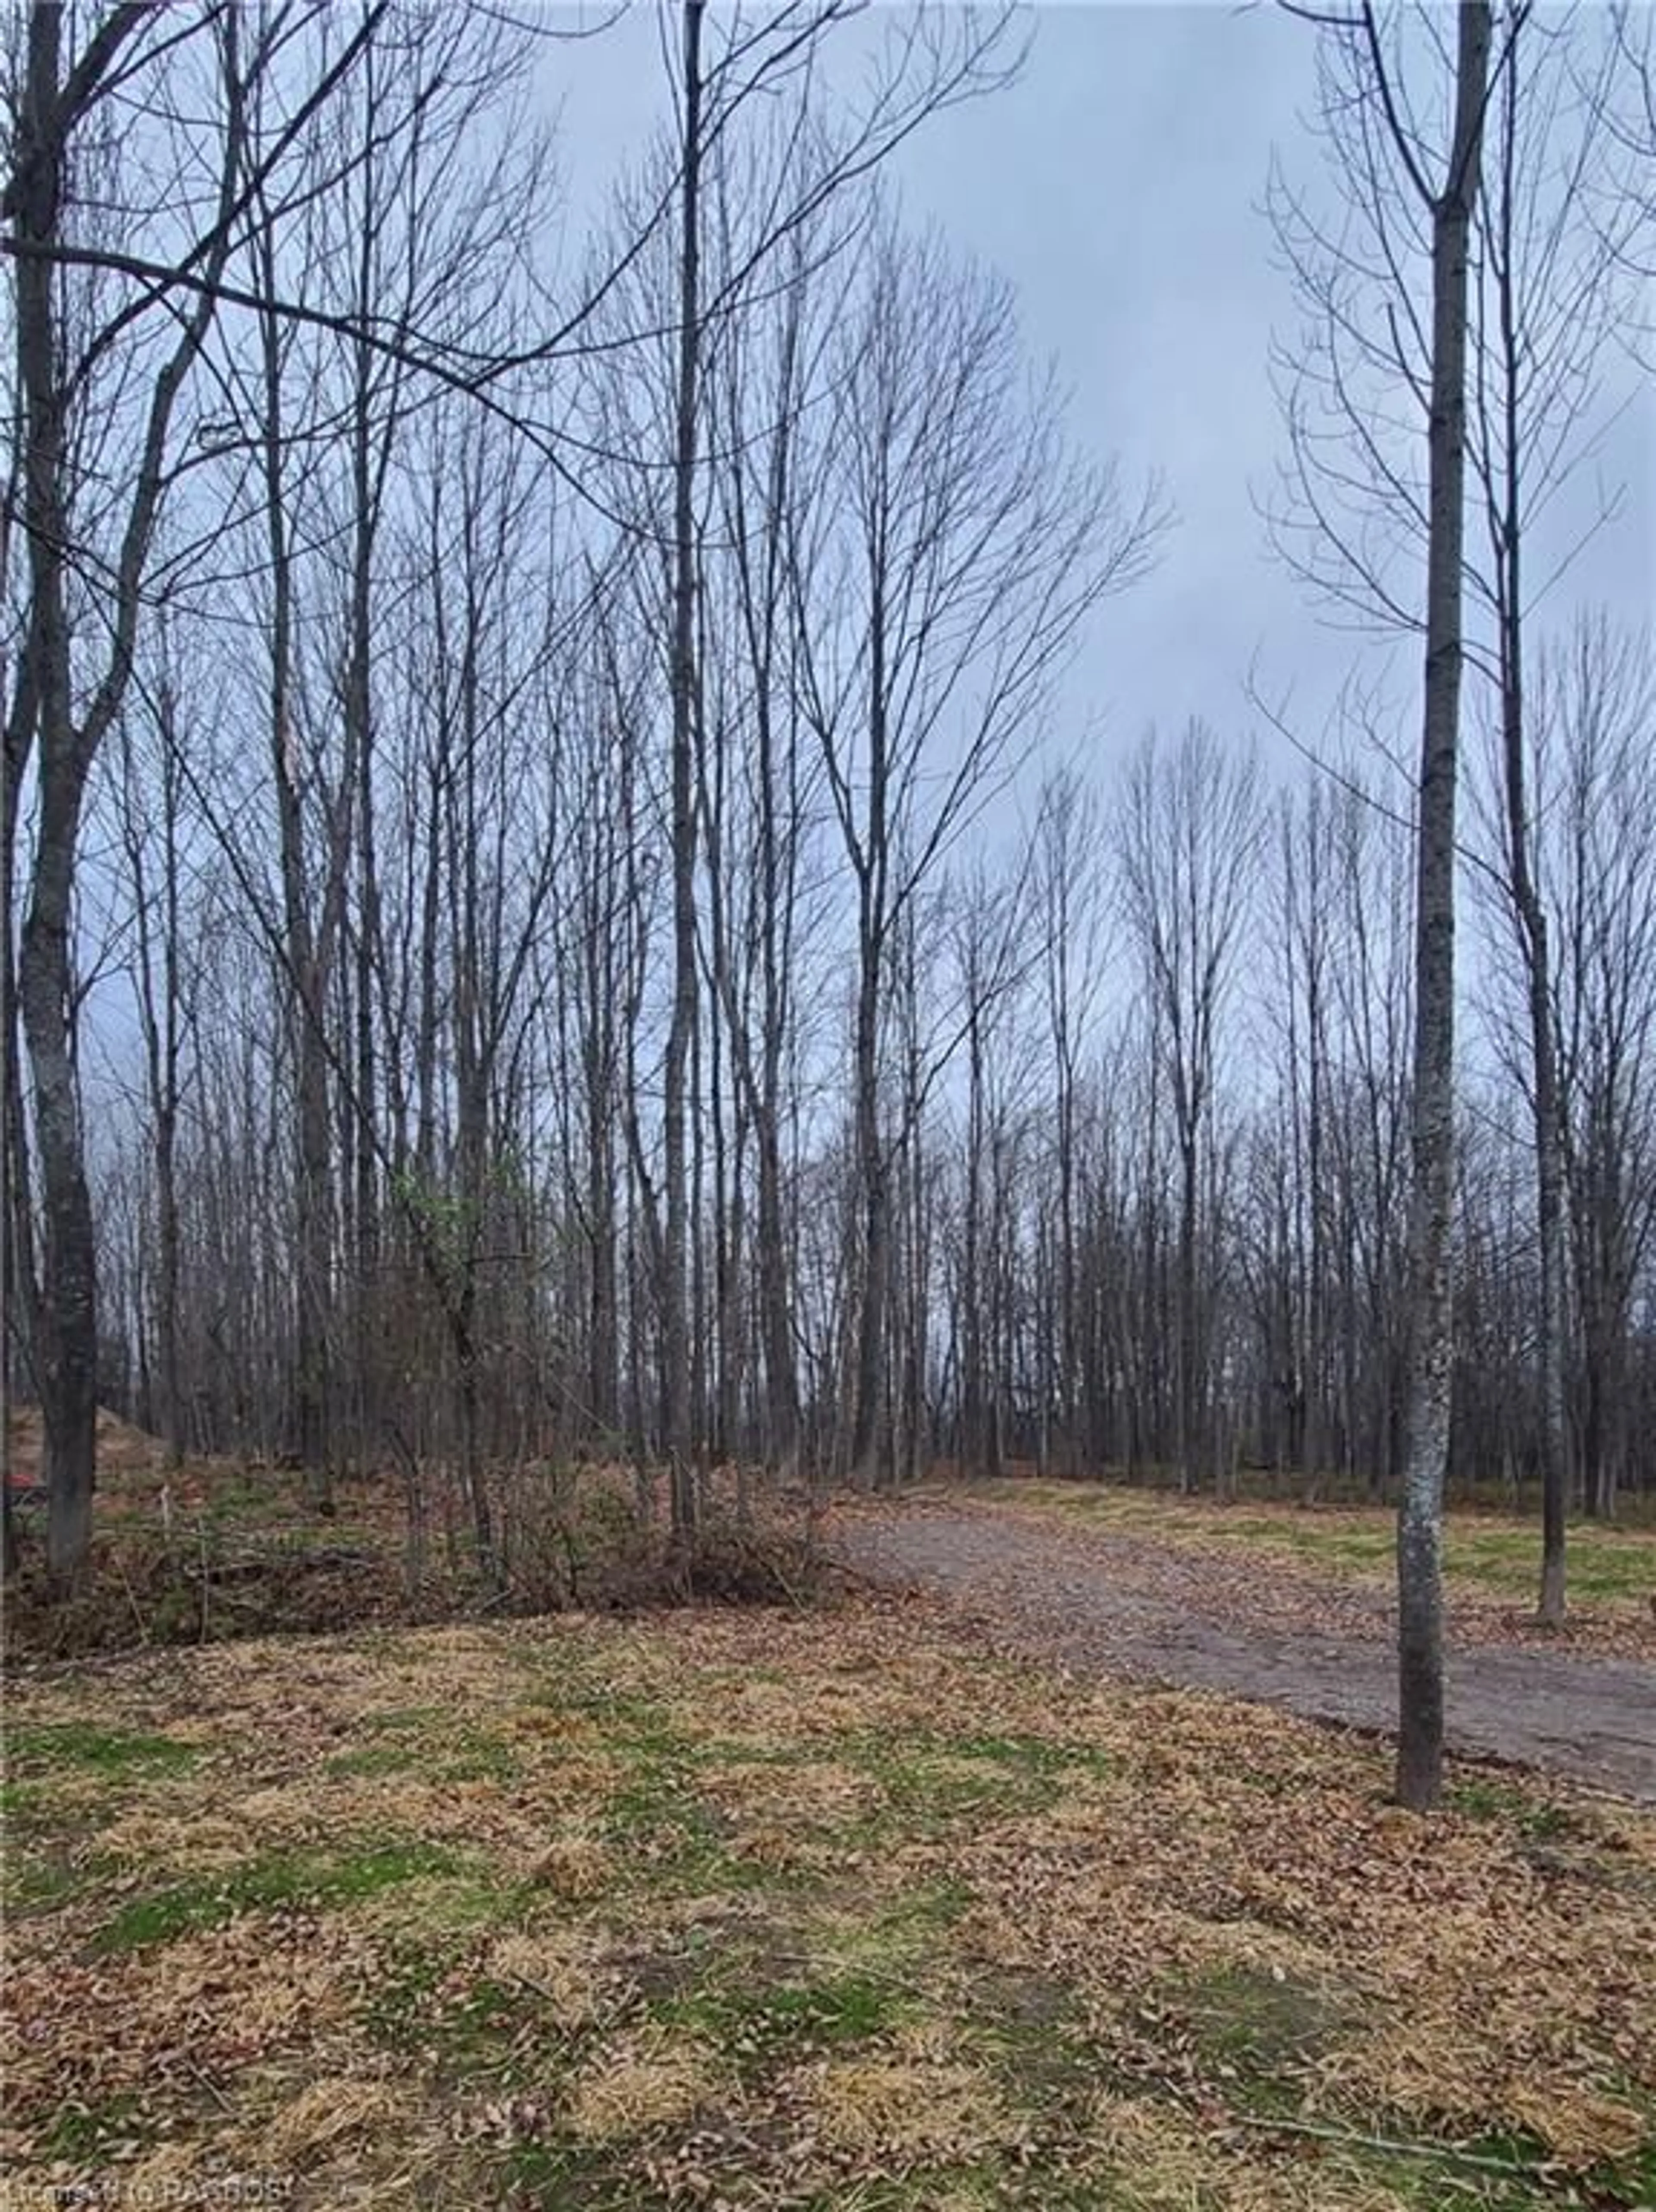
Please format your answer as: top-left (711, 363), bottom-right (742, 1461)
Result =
top-left (0, 1592), bottom-right (1656, 2212)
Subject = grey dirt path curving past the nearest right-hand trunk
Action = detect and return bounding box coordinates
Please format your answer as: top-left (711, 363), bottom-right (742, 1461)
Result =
top-left (836, 1504), bottom-right (1656, 1803)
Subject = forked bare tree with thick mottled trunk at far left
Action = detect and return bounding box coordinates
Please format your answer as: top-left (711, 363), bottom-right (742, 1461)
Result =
top-left (4, 6), bottom-right (248, 1579)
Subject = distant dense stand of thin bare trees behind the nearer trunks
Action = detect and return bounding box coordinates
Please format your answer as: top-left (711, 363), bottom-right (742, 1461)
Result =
top-left (51, 646), bottom-right (1656, 1511)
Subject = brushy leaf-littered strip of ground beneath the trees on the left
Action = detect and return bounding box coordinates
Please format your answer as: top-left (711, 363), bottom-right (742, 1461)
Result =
top-left (0, 1409), bottom-right (822, 1663)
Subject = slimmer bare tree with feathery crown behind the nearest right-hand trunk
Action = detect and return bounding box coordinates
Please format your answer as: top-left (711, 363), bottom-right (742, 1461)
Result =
top-left (1271, 4), bottom-right (1643, 1622)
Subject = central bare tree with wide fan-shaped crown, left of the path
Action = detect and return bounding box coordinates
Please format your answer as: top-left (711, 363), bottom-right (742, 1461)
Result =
top-left (794, 221), bottom-right (1158, 1482)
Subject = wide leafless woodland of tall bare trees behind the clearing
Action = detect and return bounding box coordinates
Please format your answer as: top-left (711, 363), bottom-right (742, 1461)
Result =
top-left (2, 6), bottom-right (1656, 1592)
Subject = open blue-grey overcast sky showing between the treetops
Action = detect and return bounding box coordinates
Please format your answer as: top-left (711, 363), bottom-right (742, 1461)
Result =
top-left (546, 0), bottom-right (1656, 814)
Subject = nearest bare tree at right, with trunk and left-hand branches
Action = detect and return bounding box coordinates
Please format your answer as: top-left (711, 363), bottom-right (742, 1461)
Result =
top-left (1276, 0), bottom-right (1494, 1810)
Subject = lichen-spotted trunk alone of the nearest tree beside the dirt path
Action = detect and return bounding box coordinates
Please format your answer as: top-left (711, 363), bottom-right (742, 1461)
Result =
top-left (1397, 0), bottom-right (1490, 1812)
